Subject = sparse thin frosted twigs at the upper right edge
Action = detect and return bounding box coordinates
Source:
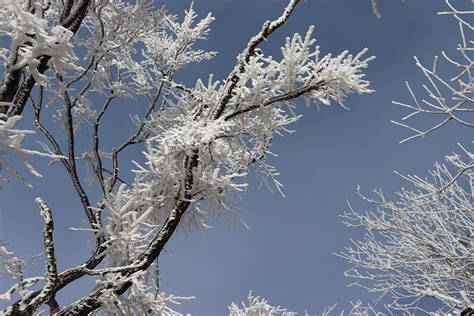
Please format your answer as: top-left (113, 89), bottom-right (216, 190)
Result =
top-left (393, 0), bottom-right (474, 143)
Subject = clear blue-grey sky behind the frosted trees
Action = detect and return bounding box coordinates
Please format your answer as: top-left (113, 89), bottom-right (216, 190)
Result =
top-left (0, 0), bottom-right (472, 315)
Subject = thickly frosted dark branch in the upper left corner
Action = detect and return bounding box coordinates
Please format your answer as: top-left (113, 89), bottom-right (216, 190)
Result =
top-left (0, 0), bottom-right (90, 115)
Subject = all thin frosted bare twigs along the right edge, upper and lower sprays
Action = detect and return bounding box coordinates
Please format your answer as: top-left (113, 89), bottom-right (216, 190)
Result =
top-left (340, 0), bottom-right (474, 315)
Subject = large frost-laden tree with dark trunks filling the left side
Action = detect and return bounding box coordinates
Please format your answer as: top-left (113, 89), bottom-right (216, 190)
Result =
top-left (0, 0), bottom-right (372, 315)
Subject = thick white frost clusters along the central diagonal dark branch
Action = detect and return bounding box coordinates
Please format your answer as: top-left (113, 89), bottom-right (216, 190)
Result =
top-left (80, 1), bottom-right (373, 311)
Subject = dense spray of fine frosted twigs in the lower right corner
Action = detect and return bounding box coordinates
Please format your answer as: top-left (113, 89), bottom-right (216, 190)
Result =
top-left (341, 147), bottom-right (474, 312)
